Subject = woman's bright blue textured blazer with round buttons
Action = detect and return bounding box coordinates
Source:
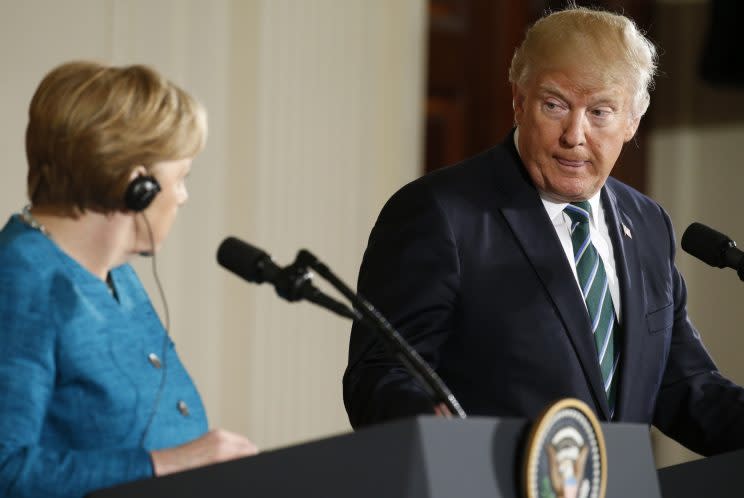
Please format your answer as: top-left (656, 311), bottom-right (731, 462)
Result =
top-left (0, 216), bottom-right (207, 497)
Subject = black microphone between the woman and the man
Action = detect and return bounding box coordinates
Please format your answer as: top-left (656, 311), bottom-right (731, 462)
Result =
top-left (217, 237), bottom-right (358, 320)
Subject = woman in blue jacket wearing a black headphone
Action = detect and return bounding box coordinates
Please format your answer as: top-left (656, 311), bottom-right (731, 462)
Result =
top-left (0, 62), bottom-right (256, 497)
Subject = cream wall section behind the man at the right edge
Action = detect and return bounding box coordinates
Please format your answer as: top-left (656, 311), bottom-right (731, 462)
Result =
top-left (650, 125), bottom-right (744, 467)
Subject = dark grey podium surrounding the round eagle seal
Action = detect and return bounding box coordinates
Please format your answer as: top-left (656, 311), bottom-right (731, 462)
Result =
top-left (89, 416), bottom-right (664, 498)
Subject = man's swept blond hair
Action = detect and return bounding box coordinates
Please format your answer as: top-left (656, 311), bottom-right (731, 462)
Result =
top-left (509, 4), bottom-right (657, 118)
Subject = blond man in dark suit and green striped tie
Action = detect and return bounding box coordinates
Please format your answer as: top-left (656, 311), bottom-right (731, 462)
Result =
top-left (344, 8), bottom-right (744, 454)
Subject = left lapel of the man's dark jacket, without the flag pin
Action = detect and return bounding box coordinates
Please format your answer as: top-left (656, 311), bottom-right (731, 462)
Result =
top-left (488, 142), bottom-right (610, 419)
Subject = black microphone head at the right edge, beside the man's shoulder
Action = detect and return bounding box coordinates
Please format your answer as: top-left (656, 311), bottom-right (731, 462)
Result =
top-left (682, 223), bottom-right (744, 280)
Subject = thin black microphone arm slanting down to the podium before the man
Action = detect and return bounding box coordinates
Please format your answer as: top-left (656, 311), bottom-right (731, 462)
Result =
top-left (284, 249), bottom-right (467, 419)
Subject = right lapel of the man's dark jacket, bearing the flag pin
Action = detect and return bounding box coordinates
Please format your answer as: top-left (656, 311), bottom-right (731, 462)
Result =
top-left (602, 185), bottom-right (647, 419)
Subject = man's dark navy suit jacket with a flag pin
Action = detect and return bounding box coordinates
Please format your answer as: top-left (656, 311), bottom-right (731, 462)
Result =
top-left (344, 134), bottom-right (744, 454)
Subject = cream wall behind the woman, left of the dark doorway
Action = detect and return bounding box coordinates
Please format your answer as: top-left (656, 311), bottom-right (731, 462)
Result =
top-left (0, 0), bottom-right (426, 449)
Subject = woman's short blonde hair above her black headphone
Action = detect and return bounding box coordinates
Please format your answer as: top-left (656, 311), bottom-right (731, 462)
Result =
top-left (26, 61), bottom-right (207, 216)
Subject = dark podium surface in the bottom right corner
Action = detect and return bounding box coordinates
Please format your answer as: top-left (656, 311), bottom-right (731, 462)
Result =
top-left (659, 450), bottom-right (744, 498)
